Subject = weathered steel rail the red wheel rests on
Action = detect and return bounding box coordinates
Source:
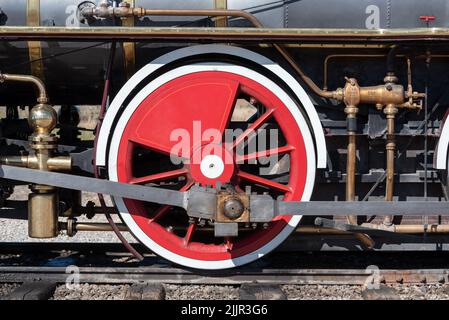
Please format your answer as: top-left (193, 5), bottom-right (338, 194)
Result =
top-left (0, 266), bottom-right (449, 285)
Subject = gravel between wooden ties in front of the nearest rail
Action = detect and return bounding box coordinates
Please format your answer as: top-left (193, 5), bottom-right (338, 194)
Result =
top-left (46, 284), bottom-right (449, 300)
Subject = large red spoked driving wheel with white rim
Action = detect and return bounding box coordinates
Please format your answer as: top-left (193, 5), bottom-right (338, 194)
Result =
top-left (107, 62), bottom-right (315, 269)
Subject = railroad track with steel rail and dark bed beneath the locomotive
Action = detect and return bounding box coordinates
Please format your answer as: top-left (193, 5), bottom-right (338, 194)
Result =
top-left (0, 243), bottom-right (449, 298)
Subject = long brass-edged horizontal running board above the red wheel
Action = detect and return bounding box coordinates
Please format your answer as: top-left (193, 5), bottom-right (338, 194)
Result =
top-left (0, 26), bottom-right (449, 43)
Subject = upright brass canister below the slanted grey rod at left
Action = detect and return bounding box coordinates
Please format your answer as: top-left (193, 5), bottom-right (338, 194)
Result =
top-left (28, 190), bottom-right (59, 239)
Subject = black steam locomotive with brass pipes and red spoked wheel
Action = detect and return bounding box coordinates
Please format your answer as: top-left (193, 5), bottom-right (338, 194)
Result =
top-left (0, 0), bottom-right (449, 269)
